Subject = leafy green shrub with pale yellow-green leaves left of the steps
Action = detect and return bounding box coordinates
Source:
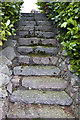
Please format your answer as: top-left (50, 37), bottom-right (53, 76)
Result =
top-left (0, 2), bottom-right (23, 45)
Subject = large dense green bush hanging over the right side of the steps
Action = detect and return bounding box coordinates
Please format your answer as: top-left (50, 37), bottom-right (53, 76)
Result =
top-left (37, 2), bottom-right (80, 75)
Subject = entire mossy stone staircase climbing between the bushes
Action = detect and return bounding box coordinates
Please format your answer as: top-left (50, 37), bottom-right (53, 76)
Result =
top-left (7, 13), bottom-right (74, 119)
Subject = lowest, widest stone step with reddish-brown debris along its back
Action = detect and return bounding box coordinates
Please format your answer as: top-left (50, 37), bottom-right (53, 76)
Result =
top-left (7, 103), bottom-right (75, 120)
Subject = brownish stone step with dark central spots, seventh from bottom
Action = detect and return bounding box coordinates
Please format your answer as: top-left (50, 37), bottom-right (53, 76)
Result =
top-left (18, 37), bottom-right (57, 46)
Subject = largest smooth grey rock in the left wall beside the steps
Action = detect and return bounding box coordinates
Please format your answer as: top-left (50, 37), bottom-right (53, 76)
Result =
top-left (0, 47), bottom-right (16, 60)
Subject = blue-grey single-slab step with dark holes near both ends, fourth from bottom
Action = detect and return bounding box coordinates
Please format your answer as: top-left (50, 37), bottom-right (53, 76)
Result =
top-left (13, 66), bottom-right (60, 76)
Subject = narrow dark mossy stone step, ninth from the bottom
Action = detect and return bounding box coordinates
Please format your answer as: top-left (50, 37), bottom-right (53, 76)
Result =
top-left (19, 25), bottom-right (54, 32)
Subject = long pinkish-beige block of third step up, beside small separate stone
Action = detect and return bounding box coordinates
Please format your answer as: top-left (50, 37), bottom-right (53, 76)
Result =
top-left (22, 76), bottom-right (68, 90)
